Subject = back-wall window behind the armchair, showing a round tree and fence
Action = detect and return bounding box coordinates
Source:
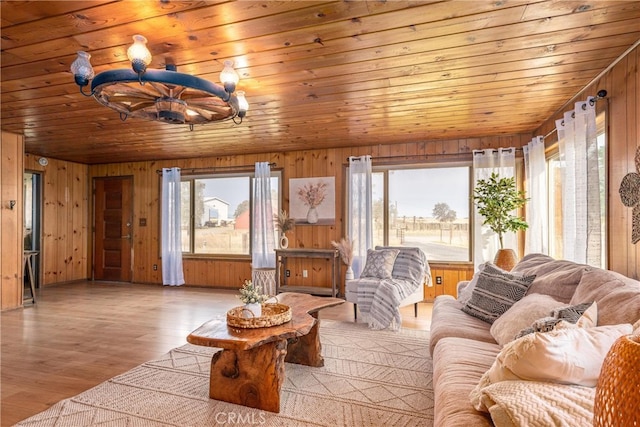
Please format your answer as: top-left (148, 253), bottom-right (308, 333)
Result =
top-left (372, 166), bottom-right (471, 262)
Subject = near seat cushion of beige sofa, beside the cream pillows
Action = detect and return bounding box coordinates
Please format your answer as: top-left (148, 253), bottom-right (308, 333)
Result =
top-left (433, 340), bottom-right (500, 427)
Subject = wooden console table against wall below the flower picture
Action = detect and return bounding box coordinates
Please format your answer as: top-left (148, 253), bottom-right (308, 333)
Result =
top-left (276, 248), bottom-right (340, 298)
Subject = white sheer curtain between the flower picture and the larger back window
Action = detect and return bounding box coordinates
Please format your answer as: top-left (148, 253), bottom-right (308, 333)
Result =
top-left (347, 156), bottom-right (373, 279)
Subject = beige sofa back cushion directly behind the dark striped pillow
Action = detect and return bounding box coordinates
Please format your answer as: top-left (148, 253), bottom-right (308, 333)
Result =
top-left (511, 254), bottom-right (589, 303)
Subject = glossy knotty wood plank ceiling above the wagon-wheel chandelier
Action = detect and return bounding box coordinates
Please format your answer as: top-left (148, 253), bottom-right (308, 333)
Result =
top-left (1, 0), bottom-right (640, 164)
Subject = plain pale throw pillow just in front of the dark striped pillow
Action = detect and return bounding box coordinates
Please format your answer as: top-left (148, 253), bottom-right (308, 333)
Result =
top-left (490, 294), bottom-right (566, 347)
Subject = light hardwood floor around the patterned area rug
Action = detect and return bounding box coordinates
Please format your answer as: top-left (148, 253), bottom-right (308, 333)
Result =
top-left (0, 282), bottom-right (432, 426)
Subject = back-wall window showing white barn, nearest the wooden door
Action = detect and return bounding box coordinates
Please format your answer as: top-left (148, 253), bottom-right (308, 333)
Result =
top-left (181, 171), bottom-right (280, 256)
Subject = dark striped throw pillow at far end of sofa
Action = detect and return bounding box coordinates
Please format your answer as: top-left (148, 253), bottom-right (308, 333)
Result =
top-left (462, 264), bottom-right (536, 323)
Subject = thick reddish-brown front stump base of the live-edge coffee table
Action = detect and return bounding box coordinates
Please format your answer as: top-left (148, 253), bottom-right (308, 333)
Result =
top-left (209, 339), bottom-right (287, 412)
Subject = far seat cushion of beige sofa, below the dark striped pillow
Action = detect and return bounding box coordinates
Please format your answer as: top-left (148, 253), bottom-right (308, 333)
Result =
top-left (429, 295), bottom-right (496, 355)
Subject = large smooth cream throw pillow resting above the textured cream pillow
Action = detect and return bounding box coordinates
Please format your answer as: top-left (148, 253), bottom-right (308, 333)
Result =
top-left (481, 324), bottom-right (633, 387)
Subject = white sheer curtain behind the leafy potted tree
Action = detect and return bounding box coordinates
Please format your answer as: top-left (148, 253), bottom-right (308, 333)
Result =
top-left (473, 147), bottom-right (518, 270)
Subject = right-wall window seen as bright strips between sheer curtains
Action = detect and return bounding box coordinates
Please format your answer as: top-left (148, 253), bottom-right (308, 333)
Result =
top-left (547, 111), bottom-right (607, 268)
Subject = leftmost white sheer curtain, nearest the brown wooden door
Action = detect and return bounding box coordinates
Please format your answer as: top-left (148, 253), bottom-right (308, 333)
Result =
top-left (162, 168), bottom-right (184, 286)
